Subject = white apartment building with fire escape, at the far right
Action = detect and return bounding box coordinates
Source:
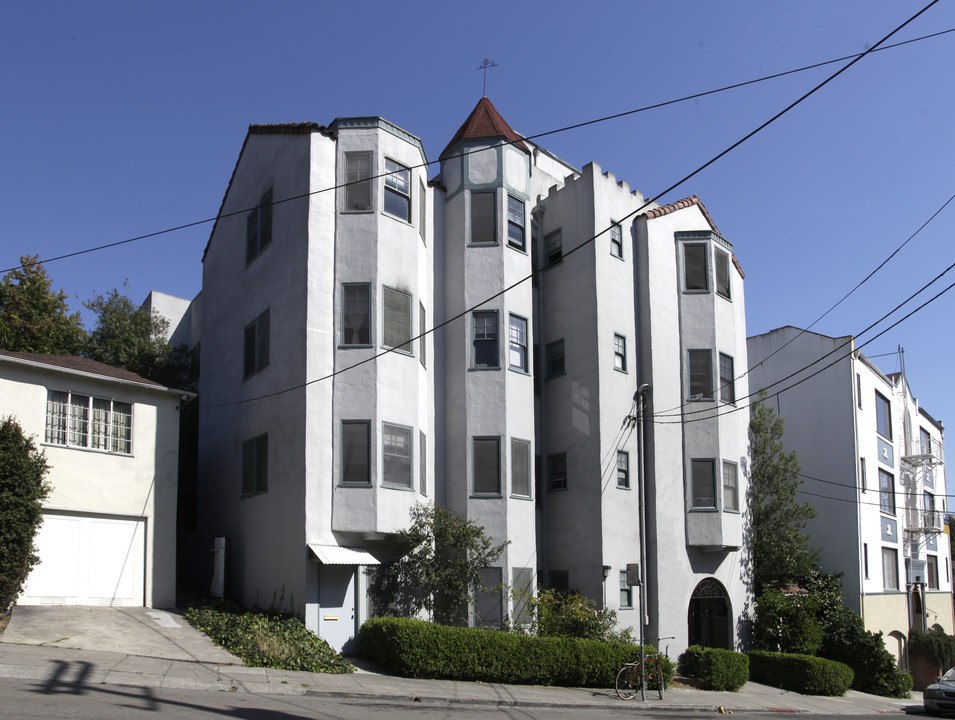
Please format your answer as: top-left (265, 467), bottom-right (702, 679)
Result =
top-left (748, 327), bottom-right (953, 665)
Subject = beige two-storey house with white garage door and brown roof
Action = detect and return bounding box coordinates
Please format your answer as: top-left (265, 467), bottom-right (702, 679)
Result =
top-left (0, 350), bottom-right (183, 607)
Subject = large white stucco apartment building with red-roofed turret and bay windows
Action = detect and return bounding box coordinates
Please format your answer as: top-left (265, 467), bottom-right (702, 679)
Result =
top-left (199, 98), bottom-right (748, 650)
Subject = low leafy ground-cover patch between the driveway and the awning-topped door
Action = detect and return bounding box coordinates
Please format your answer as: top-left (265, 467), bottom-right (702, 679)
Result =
top-left (186, 603), bottom-right (355, 673)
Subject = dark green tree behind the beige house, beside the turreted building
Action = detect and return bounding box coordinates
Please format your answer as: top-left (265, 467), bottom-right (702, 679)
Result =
top-left (83, 283), bottom-right (171, 379)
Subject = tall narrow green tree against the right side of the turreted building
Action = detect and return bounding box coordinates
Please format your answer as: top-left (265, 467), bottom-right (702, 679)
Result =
top-left (748, 402), bottom-right (818, 597)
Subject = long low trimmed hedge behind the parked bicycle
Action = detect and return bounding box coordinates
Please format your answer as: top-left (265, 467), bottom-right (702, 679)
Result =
top-left (358, 618), bottom-right (675, 687)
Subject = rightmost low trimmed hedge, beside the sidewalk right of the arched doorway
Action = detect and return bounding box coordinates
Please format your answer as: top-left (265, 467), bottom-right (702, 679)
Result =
top-left (749, 650), bottom-right (853, 696)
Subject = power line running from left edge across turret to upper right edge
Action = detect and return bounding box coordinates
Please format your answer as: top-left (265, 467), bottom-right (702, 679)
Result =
top-left (0, 22), bottom-right (955, 273)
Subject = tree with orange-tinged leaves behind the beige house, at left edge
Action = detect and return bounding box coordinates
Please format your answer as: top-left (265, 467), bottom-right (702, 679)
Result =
top-left (0, 255), bottom-right (86, 355)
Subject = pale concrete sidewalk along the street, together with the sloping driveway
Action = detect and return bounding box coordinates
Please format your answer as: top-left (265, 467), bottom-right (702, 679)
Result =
top-left (0, 607), bottom-right (922, 716)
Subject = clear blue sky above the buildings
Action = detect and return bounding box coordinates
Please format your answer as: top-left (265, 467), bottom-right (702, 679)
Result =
top-left (0, 0), bottom-right (955, 490)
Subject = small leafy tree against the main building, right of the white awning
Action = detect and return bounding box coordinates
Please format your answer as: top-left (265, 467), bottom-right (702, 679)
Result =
top-left (368, 505), bottom-right (507, 625)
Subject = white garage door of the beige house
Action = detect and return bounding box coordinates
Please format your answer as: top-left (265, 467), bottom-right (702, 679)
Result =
top-left (17, 514), bottom-right (146, 606)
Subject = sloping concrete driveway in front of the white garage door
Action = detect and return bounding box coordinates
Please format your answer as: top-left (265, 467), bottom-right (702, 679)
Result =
top-left (0, 605), bottom-right (242, 665)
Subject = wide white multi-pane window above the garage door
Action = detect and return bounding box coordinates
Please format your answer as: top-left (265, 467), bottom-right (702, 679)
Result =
top-left (44, 390), bottom-right (133, 455)
